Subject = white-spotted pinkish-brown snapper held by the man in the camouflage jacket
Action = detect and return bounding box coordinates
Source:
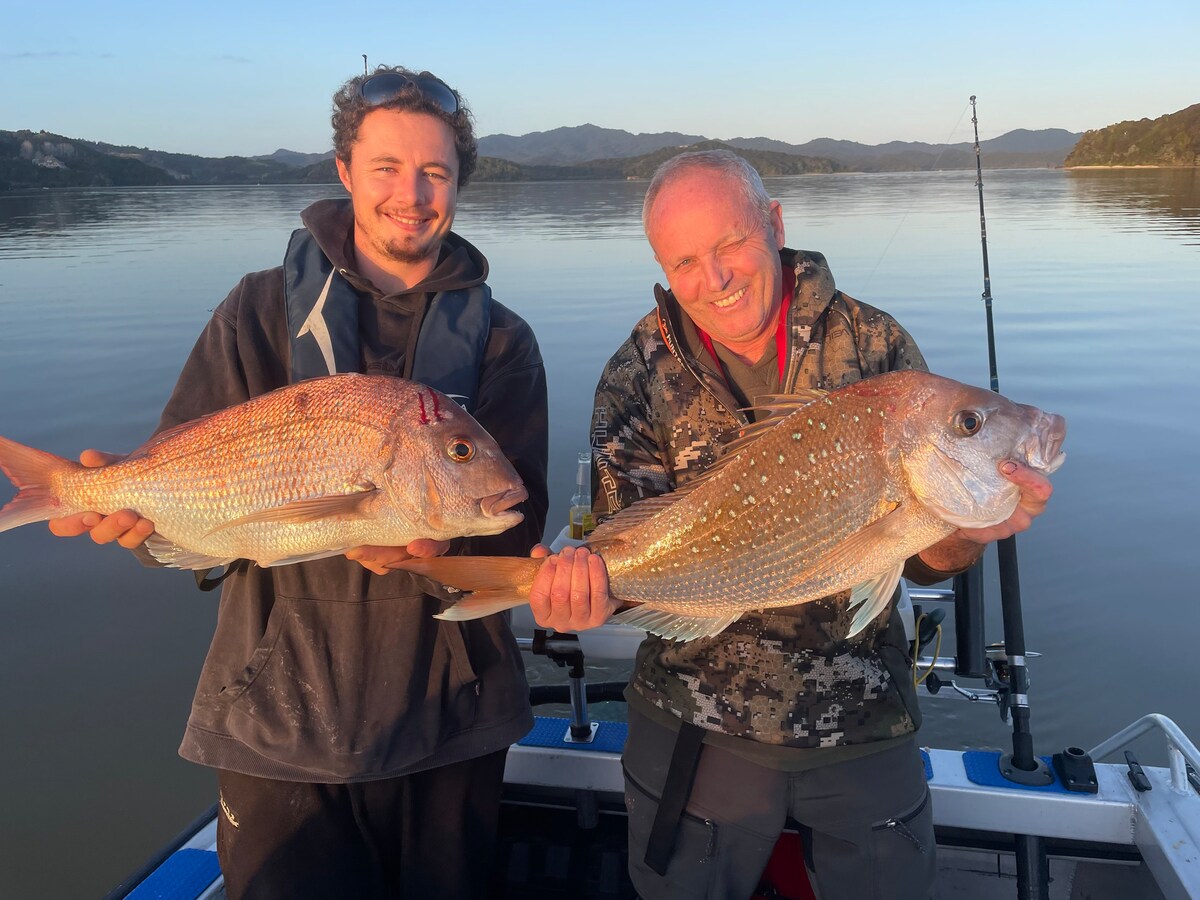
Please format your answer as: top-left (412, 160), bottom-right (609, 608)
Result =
top-left (403, 371), bottom-right (1067, 641)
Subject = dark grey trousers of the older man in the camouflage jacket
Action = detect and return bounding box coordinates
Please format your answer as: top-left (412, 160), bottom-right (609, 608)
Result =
top-left (623, 710), bottom-right (936, 900)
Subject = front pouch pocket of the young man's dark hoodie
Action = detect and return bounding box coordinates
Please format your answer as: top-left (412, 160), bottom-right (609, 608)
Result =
top-left (227, 596), bottom-right (479, 779)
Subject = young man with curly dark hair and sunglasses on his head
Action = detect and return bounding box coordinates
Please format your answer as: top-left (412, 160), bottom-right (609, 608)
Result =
top-left (52, 67), bottom-right (547, 900)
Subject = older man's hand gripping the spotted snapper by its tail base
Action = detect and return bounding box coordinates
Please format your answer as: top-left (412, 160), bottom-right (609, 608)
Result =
top-left (529, 544), bottom-right (620, 632)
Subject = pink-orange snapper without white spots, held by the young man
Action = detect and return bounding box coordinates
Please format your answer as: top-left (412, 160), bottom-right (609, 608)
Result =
top-left (0, 374), bottom-right (527, 569)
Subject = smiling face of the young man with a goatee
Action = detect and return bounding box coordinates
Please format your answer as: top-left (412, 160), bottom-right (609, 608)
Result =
top-left (337, 109), bottom-right (458, 290)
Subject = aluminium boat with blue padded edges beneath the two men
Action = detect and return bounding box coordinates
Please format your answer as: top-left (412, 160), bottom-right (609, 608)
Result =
top-left (106, 566), bottom-right (1200, 900)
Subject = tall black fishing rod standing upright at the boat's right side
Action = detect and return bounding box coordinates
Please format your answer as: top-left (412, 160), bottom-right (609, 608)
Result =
top-left (971, 95), bottom-right (1054, 900)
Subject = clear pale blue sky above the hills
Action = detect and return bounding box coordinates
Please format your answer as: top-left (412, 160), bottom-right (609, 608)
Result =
top-left (0, 0), bottom-right (1200, 156)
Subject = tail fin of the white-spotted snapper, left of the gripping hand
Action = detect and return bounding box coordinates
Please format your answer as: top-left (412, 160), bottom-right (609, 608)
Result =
top-left (396, 557), bottom-right (542, 622)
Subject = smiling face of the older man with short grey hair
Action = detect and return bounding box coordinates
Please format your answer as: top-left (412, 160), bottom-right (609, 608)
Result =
top-left (647, 169), bottom-right (784, 364)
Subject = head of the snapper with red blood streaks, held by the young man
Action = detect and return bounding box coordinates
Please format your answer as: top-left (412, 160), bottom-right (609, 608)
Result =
top-left (384, 385), bottom-right (529, 539)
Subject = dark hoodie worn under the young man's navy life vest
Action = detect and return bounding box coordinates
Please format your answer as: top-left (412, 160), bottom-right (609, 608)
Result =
top-left (158, 200), bottom-right (547, 782)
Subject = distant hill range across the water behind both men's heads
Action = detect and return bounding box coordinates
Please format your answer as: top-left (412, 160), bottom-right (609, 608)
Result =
top-left (0, 118), bottom-right (1089, 191)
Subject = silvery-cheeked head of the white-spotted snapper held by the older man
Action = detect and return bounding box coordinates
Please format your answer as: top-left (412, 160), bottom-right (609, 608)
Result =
top-left (889, 377), bottom-right (1067, 528)
